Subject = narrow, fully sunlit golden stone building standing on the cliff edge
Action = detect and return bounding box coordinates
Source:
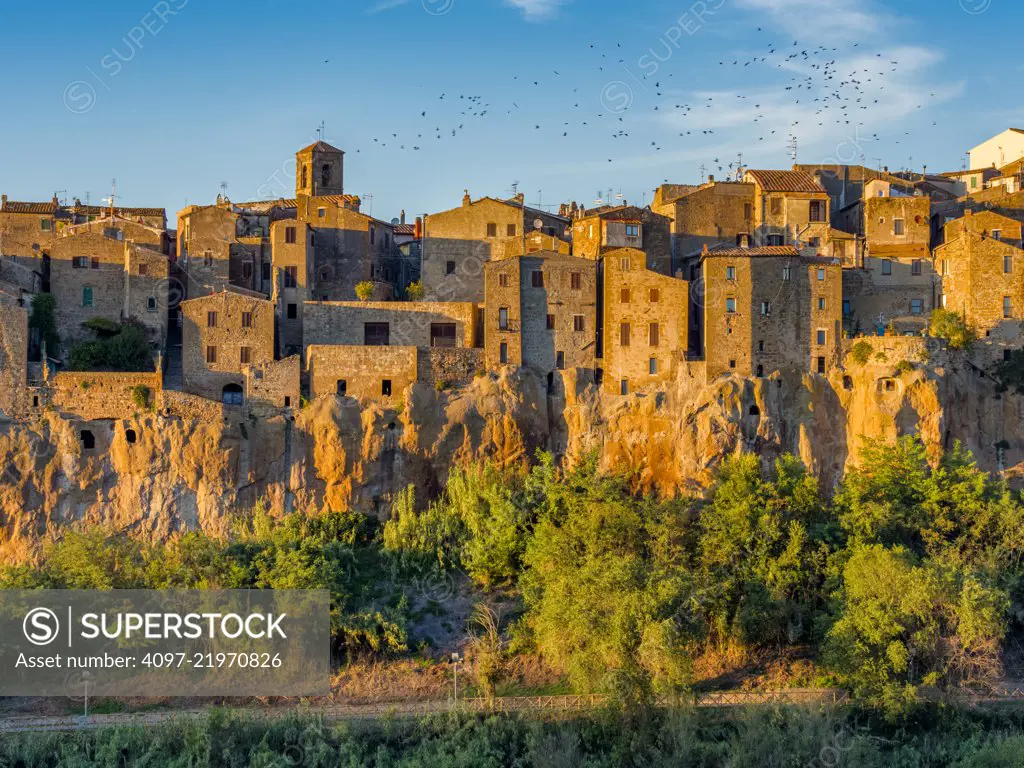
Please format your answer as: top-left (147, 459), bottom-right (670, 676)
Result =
top-left (599, 248), bottom-right (689, 394)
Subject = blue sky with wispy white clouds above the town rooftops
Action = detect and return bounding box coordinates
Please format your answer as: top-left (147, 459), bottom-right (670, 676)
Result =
top-left (0, 0), bottom-right (1024, 219)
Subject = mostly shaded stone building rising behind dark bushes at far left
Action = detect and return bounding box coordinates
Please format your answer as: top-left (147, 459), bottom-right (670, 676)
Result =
top-left (47, 229), bottom-right (170, 356)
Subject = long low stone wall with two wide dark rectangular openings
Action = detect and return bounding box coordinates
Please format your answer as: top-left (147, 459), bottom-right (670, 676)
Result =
top-left (303, 301), bottom-right (477, 347)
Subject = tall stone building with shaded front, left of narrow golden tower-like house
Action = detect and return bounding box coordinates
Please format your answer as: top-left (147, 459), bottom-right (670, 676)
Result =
top-left (483, 251), bottom-right (598, 381)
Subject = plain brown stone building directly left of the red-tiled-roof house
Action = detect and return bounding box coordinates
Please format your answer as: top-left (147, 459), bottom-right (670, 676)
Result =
top-left (651, 176), bottom-right (754, 272)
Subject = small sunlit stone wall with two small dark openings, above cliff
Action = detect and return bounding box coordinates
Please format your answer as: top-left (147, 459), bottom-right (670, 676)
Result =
top-left (306, 345), bottom-right (418, 406)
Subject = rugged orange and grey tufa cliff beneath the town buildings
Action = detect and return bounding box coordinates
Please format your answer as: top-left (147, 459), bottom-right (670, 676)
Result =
top-left (0, 353), bottom-right (1024, 560)
